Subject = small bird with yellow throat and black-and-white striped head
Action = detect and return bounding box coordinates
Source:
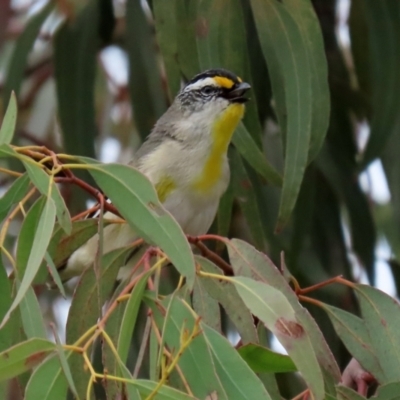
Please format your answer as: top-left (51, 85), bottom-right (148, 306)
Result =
top-left (58, 69), bottom-right (250, 282)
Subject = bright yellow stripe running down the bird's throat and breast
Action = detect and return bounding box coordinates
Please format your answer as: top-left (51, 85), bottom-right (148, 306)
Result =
top-left (193, 103), bottom-right (244, 193)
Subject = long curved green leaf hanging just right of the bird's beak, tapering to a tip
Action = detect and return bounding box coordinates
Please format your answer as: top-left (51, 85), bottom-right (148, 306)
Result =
top-left (251, 0), bottom-right (312, 232)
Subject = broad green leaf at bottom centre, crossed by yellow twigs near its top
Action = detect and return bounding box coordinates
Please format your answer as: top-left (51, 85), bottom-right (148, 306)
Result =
top-left (153, 297), bottom-right (270, 400)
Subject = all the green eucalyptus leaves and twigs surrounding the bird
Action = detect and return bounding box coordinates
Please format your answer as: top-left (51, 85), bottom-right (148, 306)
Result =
top-left (0, 0), bottom-right (400, 400)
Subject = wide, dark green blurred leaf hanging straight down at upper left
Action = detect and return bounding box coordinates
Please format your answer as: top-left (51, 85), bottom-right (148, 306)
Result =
top-left (53, 0), bottom-right (99, 157)
